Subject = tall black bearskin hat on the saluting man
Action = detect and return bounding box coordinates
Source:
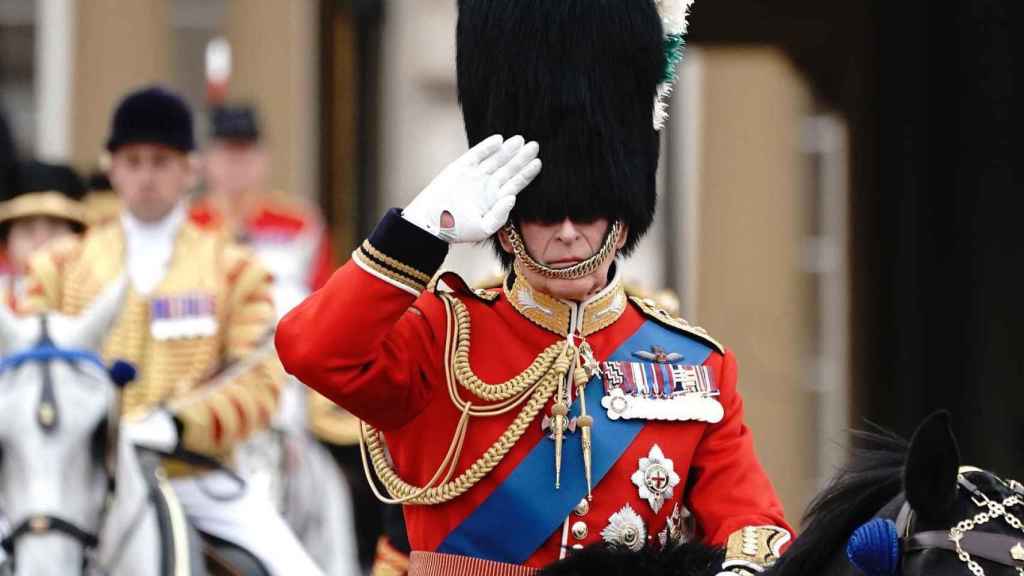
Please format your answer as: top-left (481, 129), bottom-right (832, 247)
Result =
top-left (457, 0), bottom-right (667, 263)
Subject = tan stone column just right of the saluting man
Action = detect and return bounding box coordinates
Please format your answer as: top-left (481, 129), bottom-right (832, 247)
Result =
top-left (692, 47), bottom-right (816, 510)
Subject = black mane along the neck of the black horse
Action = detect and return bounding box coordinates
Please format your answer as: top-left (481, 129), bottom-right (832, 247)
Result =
top-left (770, 425), bottom-right (909, 576)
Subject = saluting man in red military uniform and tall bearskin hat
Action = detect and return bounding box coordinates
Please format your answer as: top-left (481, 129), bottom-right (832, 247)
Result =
top-left (276, 0), bottom-right (791, 576)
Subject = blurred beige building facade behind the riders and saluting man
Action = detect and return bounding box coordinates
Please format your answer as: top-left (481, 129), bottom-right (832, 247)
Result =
top-left (0, 0), bottom-right (852, 519)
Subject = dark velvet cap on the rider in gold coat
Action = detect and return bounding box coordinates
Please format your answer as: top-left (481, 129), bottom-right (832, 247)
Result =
top-left (106, 86), bottom-right (196, 153)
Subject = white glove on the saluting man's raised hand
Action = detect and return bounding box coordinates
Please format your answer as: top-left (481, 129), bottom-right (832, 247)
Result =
top-left (401, 135), bottom-right (541, 244)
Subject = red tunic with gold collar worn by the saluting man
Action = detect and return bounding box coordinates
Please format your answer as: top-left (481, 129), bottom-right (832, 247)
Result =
top-left (276, 211), bottom-right (790, 567)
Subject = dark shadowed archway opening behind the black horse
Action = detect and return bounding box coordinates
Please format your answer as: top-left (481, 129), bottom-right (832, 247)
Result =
top-left (690, 0), bottom-right (1024, 478)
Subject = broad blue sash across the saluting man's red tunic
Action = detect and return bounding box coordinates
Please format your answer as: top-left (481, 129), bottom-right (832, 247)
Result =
top-left (436, 321), bottom-right (711, 564)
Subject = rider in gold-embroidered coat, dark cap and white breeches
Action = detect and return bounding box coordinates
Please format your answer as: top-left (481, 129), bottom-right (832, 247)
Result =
top-left (26, 87), bottom-right (321, 575)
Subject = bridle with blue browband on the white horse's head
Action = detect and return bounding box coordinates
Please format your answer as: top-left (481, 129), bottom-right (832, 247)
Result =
top-left (0, 325), bottom-right (120, 564)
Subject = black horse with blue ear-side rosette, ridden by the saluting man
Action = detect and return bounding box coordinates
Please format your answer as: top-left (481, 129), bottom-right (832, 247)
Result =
top-left (542, 412), bottom-right (1024, 576)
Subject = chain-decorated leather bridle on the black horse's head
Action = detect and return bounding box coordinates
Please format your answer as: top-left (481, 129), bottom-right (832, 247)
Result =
top-left (896, 466), bottom-right (1024, 576)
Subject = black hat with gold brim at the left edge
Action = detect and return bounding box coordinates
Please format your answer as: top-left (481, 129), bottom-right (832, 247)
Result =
top-left (0, 161), bottom-right (85, 238)
